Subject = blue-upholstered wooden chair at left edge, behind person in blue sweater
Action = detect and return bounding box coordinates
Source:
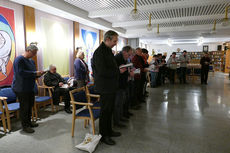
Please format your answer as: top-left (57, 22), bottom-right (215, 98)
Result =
top-left (0, 88), bottom-right (20, 131)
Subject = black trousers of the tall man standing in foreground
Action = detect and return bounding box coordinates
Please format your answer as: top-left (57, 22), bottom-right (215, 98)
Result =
top-left (99, 93), bottom-right (116, 137)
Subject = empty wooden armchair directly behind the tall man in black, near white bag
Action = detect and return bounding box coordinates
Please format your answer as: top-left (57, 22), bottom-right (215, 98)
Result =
top-left (70, 87), bottom-right (100, 137)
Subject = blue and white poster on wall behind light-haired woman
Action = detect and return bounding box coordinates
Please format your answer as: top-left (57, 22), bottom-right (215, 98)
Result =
top-left (81, 29), bottom-right (97, 71)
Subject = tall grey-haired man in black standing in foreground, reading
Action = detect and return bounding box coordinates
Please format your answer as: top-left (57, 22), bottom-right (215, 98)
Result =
top-left (92, 30), bottom-right (121, 145)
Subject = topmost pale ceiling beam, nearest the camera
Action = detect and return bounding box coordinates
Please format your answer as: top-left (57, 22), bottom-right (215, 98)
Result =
top-left (89, 0), bottom-right (230, 18)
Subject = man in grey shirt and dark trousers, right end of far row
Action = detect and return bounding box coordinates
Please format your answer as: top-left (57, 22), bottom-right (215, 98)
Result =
top-left (179, 50), bottom-right (189, 84)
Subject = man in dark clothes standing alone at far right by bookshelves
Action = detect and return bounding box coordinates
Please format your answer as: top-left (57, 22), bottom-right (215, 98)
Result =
top-left (200, 52), bottom-right (211, 84)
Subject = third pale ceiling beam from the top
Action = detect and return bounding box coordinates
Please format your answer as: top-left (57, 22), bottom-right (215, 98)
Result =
top-left (126, 24), bottom-right (230, 38)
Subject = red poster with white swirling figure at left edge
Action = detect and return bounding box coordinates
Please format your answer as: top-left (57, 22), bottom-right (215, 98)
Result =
top-left (0, 6), bottom-right (16, 86)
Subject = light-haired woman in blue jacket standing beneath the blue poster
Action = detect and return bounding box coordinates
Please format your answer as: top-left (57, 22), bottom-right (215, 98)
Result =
top-left (74, 51), bottom-right (89, 88)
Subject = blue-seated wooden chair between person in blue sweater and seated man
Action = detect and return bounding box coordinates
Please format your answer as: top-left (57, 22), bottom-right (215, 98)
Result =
top-left (32, 83), bottom-right (57, 120)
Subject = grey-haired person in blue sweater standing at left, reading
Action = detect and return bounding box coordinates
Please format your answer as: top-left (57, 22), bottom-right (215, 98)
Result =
top-left (12, 43), bottom-right (45, 133)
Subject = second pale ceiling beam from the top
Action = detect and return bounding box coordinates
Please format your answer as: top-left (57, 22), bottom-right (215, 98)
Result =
top-left (112, 13), bottom-right (230, 27)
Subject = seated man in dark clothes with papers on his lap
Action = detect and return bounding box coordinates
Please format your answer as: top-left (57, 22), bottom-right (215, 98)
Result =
top-left (44, 65), bottom-right (72, 114)
